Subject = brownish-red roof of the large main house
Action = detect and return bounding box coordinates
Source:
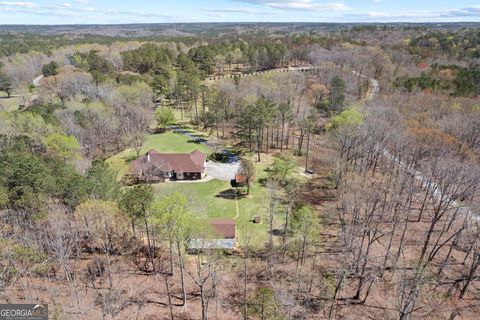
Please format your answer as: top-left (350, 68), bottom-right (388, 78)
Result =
top-left (130, 149), bottom-right (206, 173)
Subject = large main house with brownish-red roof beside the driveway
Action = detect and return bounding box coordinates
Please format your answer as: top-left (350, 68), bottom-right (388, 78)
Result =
top-left (127, 149), bottom-right (206, 182)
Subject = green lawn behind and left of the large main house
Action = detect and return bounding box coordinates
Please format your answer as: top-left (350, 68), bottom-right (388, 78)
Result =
top-left (107, 132), bottom-right (212, 179)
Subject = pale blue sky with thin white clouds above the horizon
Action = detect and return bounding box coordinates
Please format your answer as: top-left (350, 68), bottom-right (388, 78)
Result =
top-left (0, 0), bottom-right (480, 24)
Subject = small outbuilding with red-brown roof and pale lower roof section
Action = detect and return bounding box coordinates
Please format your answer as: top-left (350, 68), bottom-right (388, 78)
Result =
top-left (188, 219), bottom-right (237, 252)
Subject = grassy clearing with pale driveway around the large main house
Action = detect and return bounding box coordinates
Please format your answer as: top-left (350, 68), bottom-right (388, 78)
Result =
top-left (107, 131), bottom-right (283, 248)
